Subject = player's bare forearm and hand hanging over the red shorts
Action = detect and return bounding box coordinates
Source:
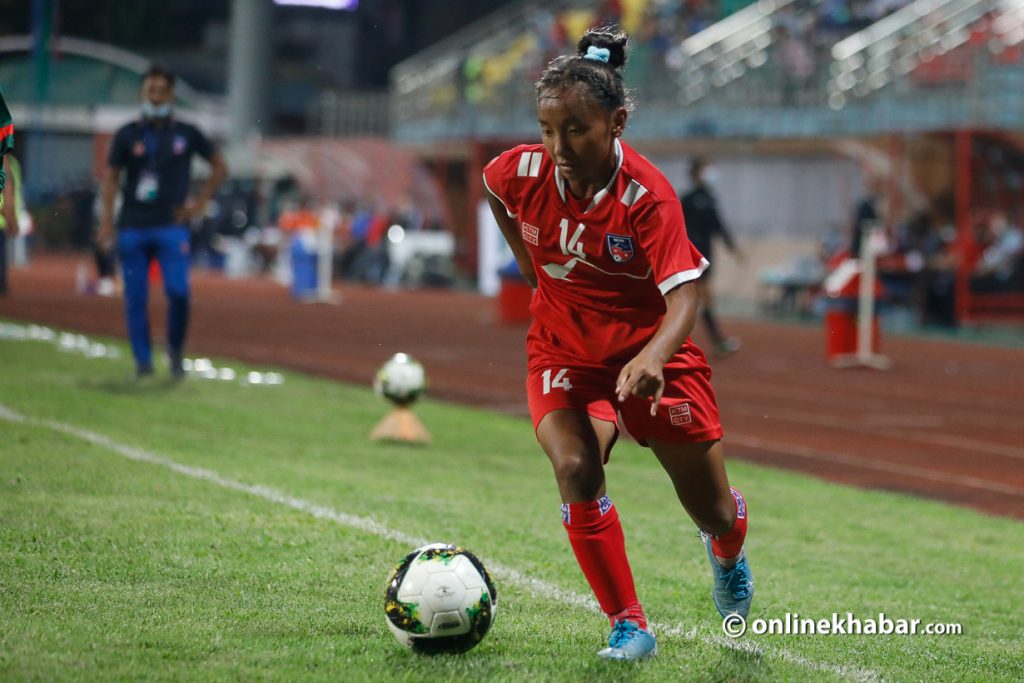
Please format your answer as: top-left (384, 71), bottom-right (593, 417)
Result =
top-left (615, 282), bottom-right (697, 415)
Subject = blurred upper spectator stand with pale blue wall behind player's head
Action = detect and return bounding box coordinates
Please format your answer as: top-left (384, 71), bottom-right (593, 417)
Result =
top-left (392, 0), bottom-right (1024, 142)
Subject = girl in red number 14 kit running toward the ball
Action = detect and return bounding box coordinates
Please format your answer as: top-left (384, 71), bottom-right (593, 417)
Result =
top-left (483, 28), bottom-right (754, 659)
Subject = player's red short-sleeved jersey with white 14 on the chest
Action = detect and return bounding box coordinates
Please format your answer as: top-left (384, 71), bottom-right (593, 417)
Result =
top-left (483, 138), bottom-right (708, 365)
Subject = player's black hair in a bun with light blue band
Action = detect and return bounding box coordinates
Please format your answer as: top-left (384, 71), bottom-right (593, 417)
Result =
top-left (537, 27), bottom-right (633, 112)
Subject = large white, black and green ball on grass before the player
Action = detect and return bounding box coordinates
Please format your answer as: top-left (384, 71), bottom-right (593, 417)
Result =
top-left (384, 543), bottom-right (498, 654)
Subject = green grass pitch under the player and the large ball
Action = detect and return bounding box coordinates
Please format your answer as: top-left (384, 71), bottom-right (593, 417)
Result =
top-left (0, 327), bottom-right (1024, 681)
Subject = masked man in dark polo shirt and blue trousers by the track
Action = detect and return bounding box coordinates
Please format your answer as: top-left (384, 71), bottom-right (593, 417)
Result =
top-left (97, 67), bottom-right (227, 378)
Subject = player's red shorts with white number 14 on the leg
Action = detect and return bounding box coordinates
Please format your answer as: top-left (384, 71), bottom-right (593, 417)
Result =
top-left (526, 348), bottom-right (722, 445)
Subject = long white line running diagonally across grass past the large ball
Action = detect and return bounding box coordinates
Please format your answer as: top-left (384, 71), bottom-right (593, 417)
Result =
top-left (0, 403), bottom-right (881, 681)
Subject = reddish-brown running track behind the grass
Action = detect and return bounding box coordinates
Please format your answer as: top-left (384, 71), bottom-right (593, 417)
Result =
top-left (0, 257), bottom-right (1024, 519)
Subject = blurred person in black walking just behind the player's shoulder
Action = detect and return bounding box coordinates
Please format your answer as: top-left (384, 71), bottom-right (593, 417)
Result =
top-left (679, 159), bottom-right (745, 356)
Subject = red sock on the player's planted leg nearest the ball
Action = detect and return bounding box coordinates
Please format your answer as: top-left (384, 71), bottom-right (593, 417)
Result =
top-left (562, 496), bottom-right (647, 629)
